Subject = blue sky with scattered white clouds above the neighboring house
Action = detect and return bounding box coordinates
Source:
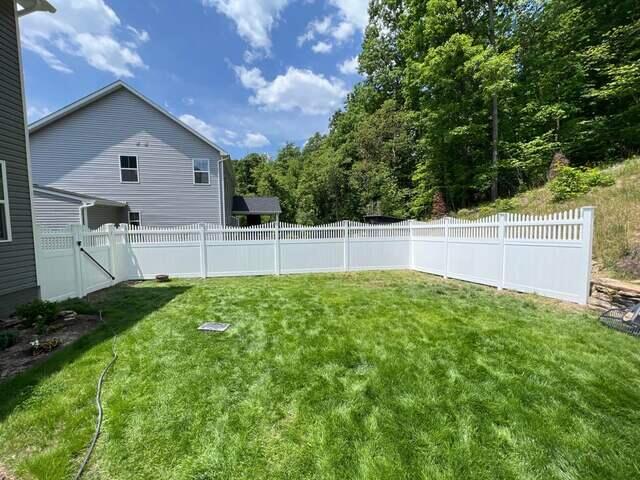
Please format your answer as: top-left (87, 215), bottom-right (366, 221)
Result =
top-left (20, 0), bottom-right (367, 158)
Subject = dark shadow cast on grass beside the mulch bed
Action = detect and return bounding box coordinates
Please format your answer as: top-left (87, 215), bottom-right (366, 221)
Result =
top-left (0, 284), bottom-right (190, 421)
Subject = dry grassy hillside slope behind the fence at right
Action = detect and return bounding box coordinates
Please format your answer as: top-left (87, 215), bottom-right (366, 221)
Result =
top-left (455, 157), bottom-right (640, 280)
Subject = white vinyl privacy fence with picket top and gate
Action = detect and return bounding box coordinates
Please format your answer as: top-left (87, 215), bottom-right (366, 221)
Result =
top-left (36, 207), bottom-right (593, 303)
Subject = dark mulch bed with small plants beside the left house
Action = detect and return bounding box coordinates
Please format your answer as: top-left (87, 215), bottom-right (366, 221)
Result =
top-left (0, 314), bottom-right (100, 380)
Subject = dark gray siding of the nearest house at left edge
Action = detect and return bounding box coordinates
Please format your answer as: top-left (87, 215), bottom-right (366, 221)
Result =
top-left (0, 0), bottom-right (37, 315)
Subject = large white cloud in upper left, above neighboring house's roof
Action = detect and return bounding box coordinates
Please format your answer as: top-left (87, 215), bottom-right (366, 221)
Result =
top-left (21, 0), bottom-right (149, 77)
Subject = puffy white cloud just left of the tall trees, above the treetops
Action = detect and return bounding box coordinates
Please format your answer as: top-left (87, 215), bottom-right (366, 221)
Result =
top-left (234, 66), bottom-right (347, 115)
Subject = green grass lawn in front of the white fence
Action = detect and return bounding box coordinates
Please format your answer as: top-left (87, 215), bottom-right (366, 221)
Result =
top-left (0, 272), bottom-right (640, 480)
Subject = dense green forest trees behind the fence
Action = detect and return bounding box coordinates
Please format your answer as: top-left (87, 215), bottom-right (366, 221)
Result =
top-left (235, 0), bottom-right (640, 224)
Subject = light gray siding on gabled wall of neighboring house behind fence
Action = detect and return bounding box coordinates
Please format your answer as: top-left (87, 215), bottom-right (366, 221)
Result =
top-left (31, 88), bottom-right (221, 225)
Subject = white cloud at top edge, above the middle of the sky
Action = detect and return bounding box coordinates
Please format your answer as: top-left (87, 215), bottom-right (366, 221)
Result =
top-left (202, 0), bottom-right (290, 51)
